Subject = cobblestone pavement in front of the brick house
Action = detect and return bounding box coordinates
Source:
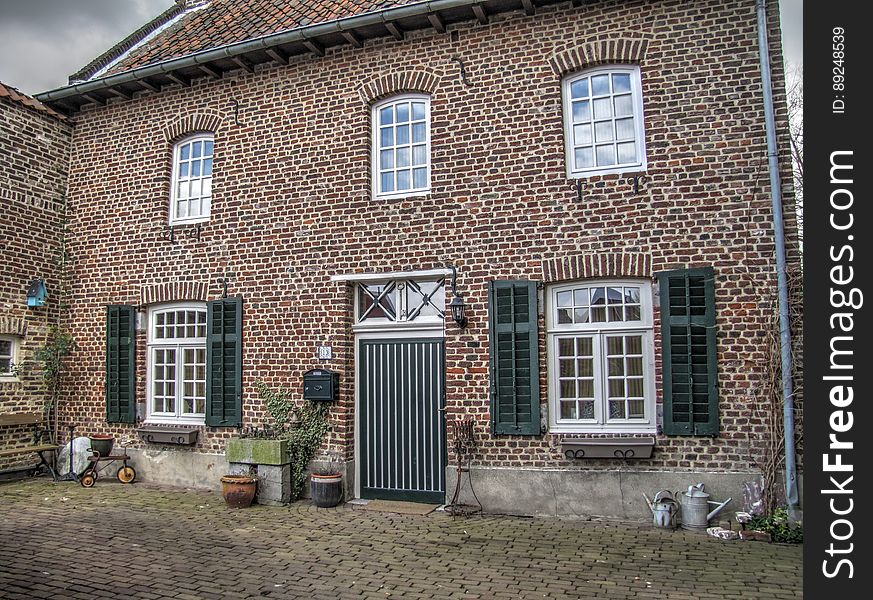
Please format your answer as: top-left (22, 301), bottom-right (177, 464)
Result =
top-left (0, 479), bottom-right (802, 600)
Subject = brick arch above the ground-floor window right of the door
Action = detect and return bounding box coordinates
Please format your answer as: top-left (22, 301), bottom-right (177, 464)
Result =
top-left (543, 252), bottom-right (652, 283)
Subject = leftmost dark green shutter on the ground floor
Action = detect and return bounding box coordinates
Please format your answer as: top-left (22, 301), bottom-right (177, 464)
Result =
top-left (106, 305), bottom-right (136, 423)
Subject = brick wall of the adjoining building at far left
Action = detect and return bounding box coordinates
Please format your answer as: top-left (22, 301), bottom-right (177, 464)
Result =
top-left (0, 97), bottom-right (72, 470)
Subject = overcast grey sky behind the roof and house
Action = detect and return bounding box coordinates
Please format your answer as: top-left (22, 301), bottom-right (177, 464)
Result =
top-left (0, 0), bottom-right (803, 94)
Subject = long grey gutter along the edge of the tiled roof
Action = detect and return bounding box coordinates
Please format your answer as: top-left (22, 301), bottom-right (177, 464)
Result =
top-left (35, 0), bottom-right (484, 103)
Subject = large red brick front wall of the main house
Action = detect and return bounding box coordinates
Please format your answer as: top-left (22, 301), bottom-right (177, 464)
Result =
top-left (58, 0), bottom-right (798, 470)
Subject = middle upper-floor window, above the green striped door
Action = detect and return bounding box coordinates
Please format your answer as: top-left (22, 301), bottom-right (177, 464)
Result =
top-left (373, 95), bottom-right (430, 198)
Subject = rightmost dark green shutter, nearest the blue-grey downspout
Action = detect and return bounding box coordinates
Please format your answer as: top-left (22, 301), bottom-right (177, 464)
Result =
top-left (658, 268), bottom-right (718, 436)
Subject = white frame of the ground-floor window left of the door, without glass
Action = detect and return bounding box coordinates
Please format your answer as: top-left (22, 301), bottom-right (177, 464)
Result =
top-left (146, 302), bottom-right (209, 425)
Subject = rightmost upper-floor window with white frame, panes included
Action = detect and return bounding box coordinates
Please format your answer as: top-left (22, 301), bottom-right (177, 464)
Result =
top-left (563, 66), bottom-right (646, 177)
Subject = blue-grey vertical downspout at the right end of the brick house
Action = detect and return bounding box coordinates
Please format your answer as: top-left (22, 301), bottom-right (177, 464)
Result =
top-left (756, 0), bottom-right (800, 516)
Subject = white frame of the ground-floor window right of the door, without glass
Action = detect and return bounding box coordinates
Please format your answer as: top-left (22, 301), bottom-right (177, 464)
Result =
top-left (546, 279), bottom-right (657, 434)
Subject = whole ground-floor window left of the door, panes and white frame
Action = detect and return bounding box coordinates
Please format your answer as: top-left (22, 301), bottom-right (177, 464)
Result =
top-left (148, 305), bottom-right (206, 422)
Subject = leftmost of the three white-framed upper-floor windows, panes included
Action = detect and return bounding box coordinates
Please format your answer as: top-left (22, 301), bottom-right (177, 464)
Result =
top-left (170, 133), bottom-right (213, 224)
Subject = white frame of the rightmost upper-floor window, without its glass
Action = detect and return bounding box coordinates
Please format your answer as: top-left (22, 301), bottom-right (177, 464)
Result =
top-left (561, 65), bottom-right (648, 179)
